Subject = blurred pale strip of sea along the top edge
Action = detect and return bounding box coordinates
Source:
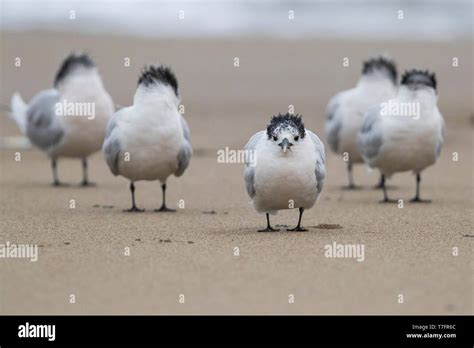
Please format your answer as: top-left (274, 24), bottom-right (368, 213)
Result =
top-left (2, 0), bottom-right (472, 41)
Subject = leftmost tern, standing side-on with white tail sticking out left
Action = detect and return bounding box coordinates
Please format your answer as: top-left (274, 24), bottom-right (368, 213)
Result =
top-left (10, 53), bottom-right (114, 186)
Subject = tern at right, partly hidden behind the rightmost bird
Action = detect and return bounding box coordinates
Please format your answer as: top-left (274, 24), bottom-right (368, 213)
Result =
top-left (324, 56), bottom-right (397, 189)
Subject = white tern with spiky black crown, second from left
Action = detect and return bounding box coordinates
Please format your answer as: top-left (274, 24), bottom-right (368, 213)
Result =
top-left (103, 65), bottom-right (193, 212)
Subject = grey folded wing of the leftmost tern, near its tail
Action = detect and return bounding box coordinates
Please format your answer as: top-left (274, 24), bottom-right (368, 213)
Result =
top-left (26, 89), bottom-right (64, 152)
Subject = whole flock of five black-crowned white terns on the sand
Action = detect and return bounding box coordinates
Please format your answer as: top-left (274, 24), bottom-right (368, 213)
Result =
top-left (11, 54), bottom-right (444, 232)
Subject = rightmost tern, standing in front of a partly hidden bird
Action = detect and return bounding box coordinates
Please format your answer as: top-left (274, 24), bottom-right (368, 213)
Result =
top-left (357, 69), bottom-right (445, 202)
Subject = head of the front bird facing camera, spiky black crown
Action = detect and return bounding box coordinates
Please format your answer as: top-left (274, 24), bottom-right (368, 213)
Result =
top-left (267, 113), bottom-right (306, 154)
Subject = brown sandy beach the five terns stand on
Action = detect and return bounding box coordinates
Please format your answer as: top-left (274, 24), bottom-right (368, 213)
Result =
top-left (0, 33), bottom-right (473, 314)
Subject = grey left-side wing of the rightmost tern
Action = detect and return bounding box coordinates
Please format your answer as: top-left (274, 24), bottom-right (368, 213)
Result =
top-left (357, 105), bottom-right (383, 165)
